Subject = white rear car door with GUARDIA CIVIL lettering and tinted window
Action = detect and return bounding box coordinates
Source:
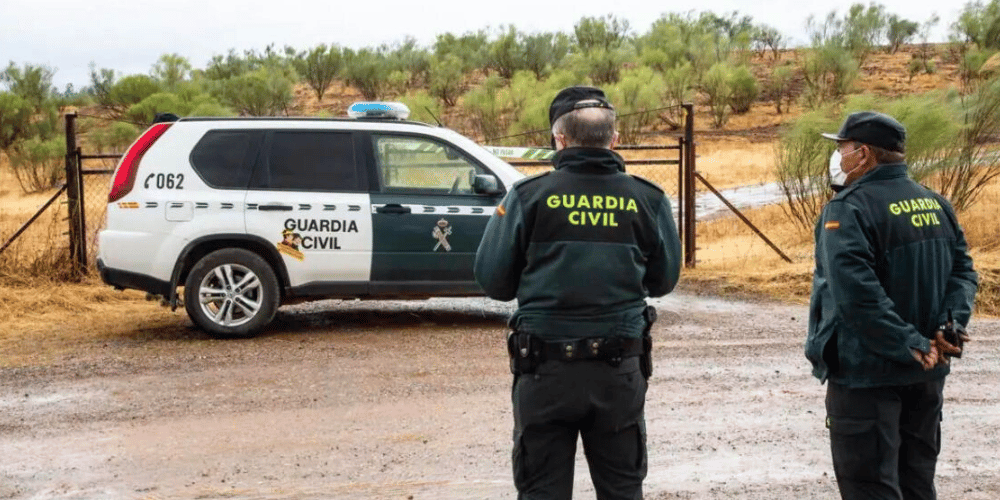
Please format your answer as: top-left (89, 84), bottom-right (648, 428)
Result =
top-left (246, 128), bottom-right (372, 296)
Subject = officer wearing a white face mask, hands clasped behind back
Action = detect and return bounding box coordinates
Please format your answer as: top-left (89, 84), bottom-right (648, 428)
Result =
top-left (805, 111), bottom-right (978, 500)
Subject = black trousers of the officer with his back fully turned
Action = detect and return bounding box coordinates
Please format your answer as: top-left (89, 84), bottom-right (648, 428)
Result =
top-left (511, 357), bottom-right (647, 500)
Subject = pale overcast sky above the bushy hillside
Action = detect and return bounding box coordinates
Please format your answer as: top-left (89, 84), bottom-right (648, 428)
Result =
top-left (0, 0), bottom-right (964, 90)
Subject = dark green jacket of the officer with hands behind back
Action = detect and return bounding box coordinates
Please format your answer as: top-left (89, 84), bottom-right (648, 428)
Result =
top-left (805, 163), bottom-right (978, 388)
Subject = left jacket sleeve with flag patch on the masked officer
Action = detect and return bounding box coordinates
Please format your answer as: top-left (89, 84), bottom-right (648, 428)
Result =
top-left (816, 200), bottom-right (930, 364)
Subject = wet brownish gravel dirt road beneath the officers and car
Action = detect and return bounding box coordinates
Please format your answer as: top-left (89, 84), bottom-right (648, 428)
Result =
top-left (0, 293), bottom-right (1000, 500)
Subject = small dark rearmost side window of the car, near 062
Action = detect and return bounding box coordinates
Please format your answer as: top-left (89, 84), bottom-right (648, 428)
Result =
top-left (191, 130), bottom-right (262, 189)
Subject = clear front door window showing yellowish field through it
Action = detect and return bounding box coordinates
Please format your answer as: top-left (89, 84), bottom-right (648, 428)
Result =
top-left (374, 135), bottom-right (485, 194)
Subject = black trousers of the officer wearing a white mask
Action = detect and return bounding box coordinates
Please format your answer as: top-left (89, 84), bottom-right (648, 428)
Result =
top-left (826, 378), bottom-right (944, 500)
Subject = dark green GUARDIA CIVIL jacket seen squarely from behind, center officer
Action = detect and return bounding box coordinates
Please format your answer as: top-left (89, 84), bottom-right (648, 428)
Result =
top-left (475, 148), bottom-right (680, 340)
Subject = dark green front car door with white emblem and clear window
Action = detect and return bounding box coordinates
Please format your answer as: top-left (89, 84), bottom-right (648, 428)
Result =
top-left (371, 133), bottom-right (502, 296)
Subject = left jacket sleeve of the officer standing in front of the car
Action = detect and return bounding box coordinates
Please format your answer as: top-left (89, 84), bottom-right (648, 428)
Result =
top-left (473, 189), bottom-right (527, 301)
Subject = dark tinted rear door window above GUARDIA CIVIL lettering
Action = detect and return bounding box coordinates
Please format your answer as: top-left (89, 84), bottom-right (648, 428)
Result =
top-left (254, 130), bottom-right (361, 191)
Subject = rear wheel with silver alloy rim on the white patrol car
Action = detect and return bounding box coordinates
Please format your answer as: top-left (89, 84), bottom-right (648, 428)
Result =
top-left (184, 248), bottom-right (280, 338)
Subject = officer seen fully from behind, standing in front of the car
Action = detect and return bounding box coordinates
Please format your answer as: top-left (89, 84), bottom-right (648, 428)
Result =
top-left (475, 87), bottom-right (680, 499)
